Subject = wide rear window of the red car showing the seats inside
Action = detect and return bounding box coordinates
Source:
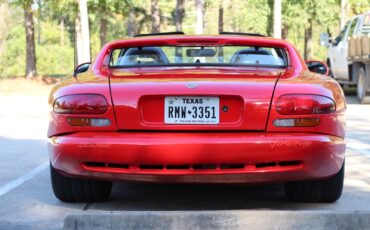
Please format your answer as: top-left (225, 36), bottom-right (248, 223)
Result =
top-left (110, 46), bottom-right (288, 68)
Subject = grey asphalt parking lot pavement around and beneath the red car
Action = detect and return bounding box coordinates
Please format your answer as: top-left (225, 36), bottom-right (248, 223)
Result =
top-left (0, 92), bottom-right (370, 229)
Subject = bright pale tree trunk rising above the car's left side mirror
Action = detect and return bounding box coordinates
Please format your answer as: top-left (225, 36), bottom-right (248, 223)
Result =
top-left (76, 0), bottom-right (91, 64)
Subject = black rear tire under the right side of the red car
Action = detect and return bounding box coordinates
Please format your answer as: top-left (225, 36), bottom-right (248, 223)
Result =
top-left (285, 162), bottom-right (345, 203)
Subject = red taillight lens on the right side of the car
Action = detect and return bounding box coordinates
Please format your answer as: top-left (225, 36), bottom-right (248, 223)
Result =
top-left (276, 94), bottom-right (335, 115)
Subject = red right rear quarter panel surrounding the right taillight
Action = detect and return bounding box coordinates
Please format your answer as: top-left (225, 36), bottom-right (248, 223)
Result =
top-left (267, 70), bottom-right (346, 138)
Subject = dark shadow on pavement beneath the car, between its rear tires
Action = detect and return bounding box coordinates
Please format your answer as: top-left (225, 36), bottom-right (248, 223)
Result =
top-left (91, 183), bottom-right (286, 210)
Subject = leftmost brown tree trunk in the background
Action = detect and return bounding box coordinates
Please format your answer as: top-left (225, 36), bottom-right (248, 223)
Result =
top-left (23, 1), bottom-right (37, 78)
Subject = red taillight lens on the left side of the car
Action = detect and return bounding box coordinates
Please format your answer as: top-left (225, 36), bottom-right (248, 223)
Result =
top-left (54, 94), bottom-right (108, 114)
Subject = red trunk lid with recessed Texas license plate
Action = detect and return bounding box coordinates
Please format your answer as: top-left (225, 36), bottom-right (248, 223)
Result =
top-left (110, 67), bottom-right (285, 131)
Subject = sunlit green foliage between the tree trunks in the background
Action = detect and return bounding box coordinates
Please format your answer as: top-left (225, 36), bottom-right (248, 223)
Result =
top-left (0, 0), bottom-right (370, 77)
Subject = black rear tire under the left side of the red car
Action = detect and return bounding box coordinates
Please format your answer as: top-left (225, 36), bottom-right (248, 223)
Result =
top-left (50, 165), bottom-right (112, 202)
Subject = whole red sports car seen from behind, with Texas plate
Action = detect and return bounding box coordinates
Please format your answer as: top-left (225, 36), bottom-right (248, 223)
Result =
top-left (48, 33), bottom-right (346, 202)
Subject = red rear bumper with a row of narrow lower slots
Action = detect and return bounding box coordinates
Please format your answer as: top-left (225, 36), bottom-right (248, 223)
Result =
top-left (49, 132), bottom-right (345, 183)
